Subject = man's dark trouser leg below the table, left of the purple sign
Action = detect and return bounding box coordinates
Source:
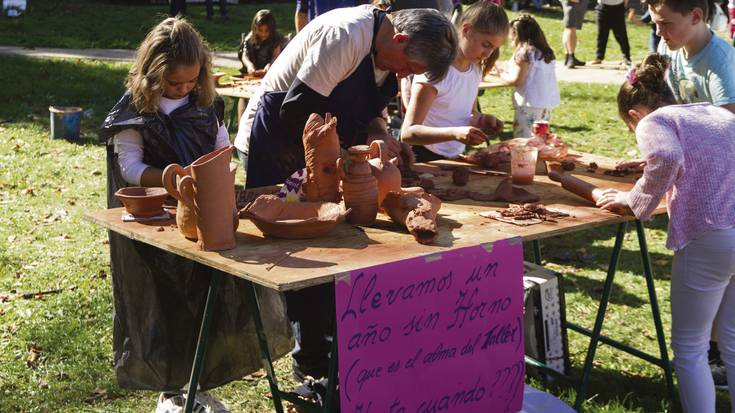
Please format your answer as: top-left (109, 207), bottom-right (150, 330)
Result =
top-left (284, 283), bottom-right (336, 381)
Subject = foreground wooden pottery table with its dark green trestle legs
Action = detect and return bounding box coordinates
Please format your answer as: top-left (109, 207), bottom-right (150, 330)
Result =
top-left (87, 151), bottom-right (673, 412)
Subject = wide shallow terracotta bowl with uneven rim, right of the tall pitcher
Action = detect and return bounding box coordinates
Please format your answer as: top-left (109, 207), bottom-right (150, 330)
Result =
top-left (240, 195), bottom-right (349, 239)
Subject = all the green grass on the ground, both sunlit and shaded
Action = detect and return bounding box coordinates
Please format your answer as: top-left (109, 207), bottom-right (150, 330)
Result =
top-left (0, 0), bottom-right (729, 413)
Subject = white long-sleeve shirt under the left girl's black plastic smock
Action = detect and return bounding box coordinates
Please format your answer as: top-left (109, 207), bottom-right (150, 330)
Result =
top-left (112, 96), bottom-right (230, 185)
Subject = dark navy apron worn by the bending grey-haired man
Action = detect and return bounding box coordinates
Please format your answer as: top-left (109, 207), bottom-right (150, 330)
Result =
top-left (245, 10), bottom-right (398, 188)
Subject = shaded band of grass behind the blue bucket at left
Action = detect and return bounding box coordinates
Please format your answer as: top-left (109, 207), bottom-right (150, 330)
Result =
top-left (0, 56), bottom-right (128, 145)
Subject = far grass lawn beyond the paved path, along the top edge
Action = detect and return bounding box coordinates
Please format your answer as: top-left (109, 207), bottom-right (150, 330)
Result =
top-left (0, 0), bottom-right (660, 60)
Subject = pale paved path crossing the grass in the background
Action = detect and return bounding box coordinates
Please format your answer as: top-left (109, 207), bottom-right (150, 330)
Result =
top-left (0, 46), bottom-right (625, 85)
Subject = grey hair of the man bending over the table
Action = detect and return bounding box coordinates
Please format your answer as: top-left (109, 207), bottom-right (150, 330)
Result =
top-left (390, 9), bottom-right (457, 82)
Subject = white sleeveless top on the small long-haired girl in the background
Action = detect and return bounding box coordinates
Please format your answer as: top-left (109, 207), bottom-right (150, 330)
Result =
top-left (513, 48), bottom-right (560, 109)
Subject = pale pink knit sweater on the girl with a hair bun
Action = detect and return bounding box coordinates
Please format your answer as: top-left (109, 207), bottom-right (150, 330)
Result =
top-left (628, 103), bottom-right (735, 250)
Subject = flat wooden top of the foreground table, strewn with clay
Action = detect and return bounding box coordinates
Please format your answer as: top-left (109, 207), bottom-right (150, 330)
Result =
top-left (86, 154), bottom-right (665, 291)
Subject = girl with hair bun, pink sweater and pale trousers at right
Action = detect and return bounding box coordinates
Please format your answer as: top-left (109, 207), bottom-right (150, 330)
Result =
top-left (597, 54), bottom-right (735, 412)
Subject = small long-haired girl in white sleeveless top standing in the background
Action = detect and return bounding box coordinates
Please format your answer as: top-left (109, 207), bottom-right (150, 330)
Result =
top-left (500, 14), bottom-right (560, 138)
